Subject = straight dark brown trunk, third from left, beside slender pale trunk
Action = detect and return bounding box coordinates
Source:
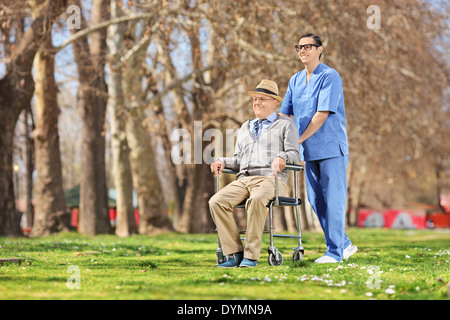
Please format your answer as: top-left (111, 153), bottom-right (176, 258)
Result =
top-left (73, 0), bottom-right (112, 235)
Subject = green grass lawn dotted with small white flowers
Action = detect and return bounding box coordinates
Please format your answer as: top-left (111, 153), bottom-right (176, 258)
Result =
top-left (0, 229), bottom-right (450, 300)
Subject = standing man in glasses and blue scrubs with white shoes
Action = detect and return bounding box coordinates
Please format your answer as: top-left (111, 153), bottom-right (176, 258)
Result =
top-left (280, 33), bottom-right (358, 263)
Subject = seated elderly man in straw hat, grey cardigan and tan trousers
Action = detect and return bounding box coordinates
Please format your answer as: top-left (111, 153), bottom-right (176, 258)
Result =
top-left (209, 80), bottom-right (300, 268)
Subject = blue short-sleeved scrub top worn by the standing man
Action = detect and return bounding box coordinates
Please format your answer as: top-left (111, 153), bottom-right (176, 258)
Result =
top-left (280, 63), bottom-right (348, 161)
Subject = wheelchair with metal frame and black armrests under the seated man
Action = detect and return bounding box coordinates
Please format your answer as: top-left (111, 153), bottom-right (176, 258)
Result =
top-left (214, 164), bottom-right (305, 266)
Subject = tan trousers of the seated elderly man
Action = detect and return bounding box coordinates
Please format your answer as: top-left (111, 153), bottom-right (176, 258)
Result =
top-left (209, 176), bottom-right (287, 260)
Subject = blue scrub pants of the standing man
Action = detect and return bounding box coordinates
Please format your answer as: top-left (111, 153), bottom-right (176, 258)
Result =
top-left (305, 155), bottom-right (351, 261)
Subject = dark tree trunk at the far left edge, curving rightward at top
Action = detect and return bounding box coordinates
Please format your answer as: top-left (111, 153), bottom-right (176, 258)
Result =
top-left (0, 0), bottom-right (66, 236)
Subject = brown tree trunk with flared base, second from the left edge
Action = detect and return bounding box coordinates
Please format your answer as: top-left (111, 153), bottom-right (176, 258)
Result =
top-left (31, 2), bottom-right (70, 236)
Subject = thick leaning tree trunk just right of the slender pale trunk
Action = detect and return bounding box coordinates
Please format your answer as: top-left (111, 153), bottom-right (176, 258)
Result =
top-left (122, 18), bottom-right (174, 234)
